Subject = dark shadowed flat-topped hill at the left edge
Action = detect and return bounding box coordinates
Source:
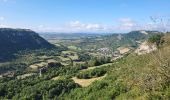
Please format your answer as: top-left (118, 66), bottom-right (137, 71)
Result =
top-left (0, 28), bottom-right (54, 61)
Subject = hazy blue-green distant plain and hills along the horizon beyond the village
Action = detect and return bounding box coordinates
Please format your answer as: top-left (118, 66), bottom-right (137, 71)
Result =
top-left (40, 30), bottom-right (160, 51)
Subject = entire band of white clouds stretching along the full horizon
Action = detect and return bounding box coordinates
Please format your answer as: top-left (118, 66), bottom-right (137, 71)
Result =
top-left (0, 17), bottom-right (170, 33)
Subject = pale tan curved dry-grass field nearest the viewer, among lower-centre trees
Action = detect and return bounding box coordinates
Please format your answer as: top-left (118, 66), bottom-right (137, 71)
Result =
top-left (72, 75), bottom-right (106, 87)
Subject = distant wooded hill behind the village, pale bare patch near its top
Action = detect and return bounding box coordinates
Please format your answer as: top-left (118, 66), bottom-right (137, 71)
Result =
top-left (88, 30), bottom-right (160, 50)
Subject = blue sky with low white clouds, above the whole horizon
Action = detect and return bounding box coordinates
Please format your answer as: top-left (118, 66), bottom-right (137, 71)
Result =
top-left (0, 0), bottom-right (170, 33)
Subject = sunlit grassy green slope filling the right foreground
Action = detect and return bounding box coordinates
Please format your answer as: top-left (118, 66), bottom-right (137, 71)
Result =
top-left (64, 33), bottom-right (170, 100)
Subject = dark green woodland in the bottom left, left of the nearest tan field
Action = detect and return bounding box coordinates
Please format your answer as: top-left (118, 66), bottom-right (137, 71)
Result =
top-left (0, 63), bottom-right (83, 99)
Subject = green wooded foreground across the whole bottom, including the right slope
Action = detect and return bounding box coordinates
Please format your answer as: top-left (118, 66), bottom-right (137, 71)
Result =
top-left (0, 34), bottom-right (170, 100)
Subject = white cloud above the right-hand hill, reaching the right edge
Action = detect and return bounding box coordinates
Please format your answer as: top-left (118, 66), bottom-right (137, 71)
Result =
top-left (113, 18), bottom-right (170, 32)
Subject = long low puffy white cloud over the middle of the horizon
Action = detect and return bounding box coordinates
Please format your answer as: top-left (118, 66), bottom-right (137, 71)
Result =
top-left (34, 21), bottom-right (109, 33)
